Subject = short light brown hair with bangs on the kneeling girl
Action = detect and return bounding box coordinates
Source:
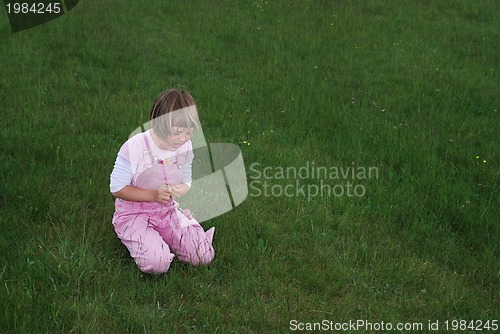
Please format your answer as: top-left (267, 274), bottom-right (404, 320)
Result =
top-left (149, 88), bottom-right (200, 137)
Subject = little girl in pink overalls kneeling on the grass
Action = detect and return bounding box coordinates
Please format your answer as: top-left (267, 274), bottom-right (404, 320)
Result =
top-left (110, 89), bottom-right (215, 274)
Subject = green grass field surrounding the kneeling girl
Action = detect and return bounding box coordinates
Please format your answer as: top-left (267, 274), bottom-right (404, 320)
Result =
top-left (0, 0), bottom-right (500, 333)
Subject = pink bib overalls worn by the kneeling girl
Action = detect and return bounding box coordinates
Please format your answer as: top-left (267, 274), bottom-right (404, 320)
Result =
top-left (113, 133), bottom-right (215, 274)
